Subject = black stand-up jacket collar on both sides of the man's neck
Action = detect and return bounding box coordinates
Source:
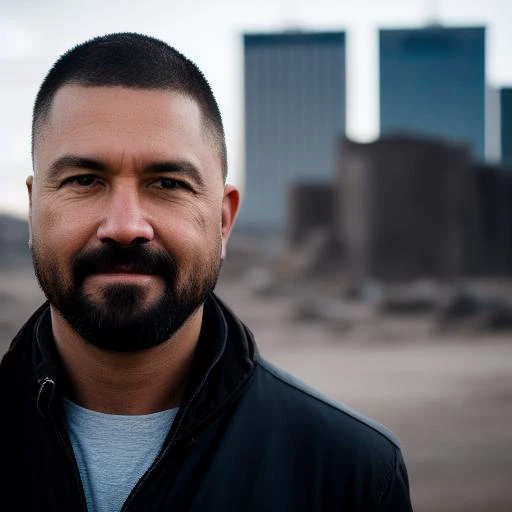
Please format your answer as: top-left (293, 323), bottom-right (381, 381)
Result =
top-left (21, 293), bottom-right (257, 428)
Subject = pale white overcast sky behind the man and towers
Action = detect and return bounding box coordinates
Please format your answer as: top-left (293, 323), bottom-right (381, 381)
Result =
top-left (0, 0), bottom-right (512, 215)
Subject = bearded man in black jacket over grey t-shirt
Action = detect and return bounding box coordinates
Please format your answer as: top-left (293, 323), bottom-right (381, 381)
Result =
top-left (0, 34), bottom-right (411, 512)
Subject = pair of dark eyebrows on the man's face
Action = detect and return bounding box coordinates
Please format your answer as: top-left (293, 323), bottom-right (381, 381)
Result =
top-left (48, 155), bottom-right (204, 187)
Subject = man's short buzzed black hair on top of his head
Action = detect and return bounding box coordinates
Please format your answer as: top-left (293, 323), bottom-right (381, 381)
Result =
top-left (32, 32), bottom-right (227, 179)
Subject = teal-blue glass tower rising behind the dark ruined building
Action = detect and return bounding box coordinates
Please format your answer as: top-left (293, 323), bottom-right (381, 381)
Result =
top-left (380, 27), bottom-right (485, 159)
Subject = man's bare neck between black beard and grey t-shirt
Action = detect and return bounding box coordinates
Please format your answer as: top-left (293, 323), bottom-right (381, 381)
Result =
top-left (51, 307), bottom-right (203, 415)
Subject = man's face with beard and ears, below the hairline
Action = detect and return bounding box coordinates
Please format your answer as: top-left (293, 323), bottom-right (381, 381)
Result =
top-left (27, 85), bottom-right (238, 351)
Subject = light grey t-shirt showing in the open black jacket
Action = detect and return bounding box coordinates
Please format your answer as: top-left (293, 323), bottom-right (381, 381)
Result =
top-left (64, 399), bottom-right (178, 512)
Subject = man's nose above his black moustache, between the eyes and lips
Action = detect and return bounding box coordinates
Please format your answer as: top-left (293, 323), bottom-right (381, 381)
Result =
top-left (97, 186), bottom-right (154, 245)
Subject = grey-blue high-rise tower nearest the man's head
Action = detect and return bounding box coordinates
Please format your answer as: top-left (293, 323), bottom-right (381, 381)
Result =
top-left (238, 32), bottom-right (345, 231)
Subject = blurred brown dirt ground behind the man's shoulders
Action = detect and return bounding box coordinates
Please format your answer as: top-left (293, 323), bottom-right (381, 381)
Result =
top-left (0, 271), bottom-right (512, 512)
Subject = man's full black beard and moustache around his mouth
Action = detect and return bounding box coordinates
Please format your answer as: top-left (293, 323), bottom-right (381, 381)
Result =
top-left (32, 242), bottom-right (220, 352)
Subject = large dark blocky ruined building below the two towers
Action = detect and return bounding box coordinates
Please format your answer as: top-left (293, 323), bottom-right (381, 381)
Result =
top-left (337, 136), bottom-right (477, 292)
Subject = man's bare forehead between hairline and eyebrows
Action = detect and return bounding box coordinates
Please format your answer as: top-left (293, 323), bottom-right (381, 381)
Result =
top-left (34, 85), bottom-right (218, 175)
